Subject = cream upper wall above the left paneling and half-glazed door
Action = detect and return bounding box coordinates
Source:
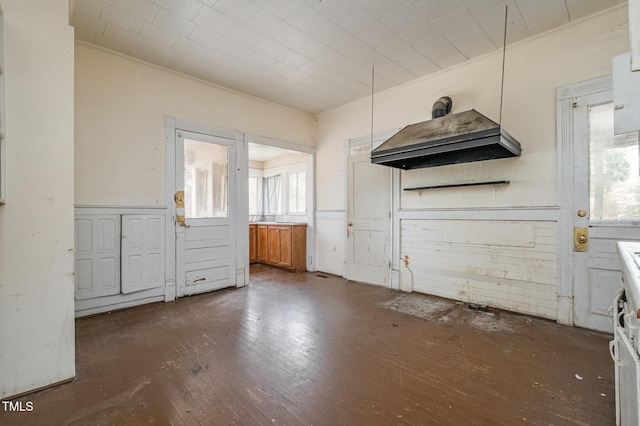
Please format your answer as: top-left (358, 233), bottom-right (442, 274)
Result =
top-left (75, 44), bottom-right (315, 207)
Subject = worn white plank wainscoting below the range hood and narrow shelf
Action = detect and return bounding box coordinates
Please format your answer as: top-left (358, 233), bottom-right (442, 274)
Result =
top-left (398, 207), bottom-right (558, 319)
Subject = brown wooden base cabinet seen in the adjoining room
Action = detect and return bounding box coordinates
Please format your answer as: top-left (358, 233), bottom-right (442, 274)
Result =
top-left (249, 223), bottom-right (307, 272)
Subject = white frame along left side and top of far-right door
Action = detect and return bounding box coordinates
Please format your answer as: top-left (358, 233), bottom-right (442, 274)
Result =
top-left (556, 75), bottom-right (613, 325)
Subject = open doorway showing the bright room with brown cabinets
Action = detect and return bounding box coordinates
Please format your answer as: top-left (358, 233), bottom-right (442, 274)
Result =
top-left (247, 142), bottom-right (315, 273)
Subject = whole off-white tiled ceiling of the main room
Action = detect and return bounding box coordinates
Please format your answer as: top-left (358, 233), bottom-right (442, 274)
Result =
top-left (71, 0), bottom-right (626, 114)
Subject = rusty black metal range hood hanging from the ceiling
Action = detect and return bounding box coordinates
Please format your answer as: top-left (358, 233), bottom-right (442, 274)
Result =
top-left (371, 106), bottom-right (521, 170)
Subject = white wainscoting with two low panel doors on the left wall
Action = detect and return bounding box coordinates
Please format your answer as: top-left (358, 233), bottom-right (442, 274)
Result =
top-left (74, 206), bottom-right (173, 317)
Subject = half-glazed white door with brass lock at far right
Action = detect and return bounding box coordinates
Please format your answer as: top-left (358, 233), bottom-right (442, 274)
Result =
top-left (572, 91), bottom-right (640, 332)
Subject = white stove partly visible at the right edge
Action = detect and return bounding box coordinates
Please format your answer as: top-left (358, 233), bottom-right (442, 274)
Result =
top-left (609, 242), bottom-right (640, 426)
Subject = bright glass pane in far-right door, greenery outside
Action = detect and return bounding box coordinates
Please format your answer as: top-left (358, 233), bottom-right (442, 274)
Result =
top-left (589, 103), bottom-right (640, 221)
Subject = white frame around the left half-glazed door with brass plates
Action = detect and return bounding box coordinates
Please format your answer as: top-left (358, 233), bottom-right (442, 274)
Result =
top-left (164, 116), bottom-right (249, 302)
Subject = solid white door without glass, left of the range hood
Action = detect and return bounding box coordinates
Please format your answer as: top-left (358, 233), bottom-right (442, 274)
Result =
top-left (346, 153), bottom-right (391, 286)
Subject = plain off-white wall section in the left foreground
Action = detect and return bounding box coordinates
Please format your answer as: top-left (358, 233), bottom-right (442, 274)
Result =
top-left (0, 0), bottom-right (75, 399)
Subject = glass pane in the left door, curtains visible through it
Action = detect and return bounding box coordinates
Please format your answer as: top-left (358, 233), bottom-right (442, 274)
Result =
top-left (184, 139), bottom-right (228, 218)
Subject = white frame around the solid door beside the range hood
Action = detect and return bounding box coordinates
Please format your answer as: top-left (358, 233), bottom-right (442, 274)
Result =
top-left (342, 128), bottom-right (400, 291)
